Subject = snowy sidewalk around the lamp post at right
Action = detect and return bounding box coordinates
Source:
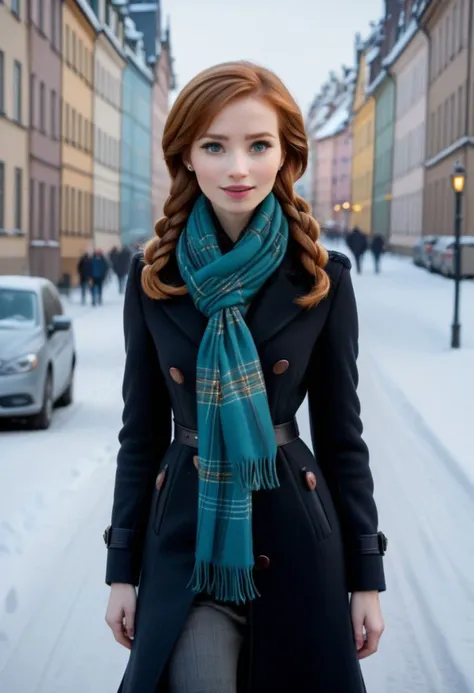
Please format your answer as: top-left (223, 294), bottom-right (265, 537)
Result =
top-left (326, 245), bottom-right (474, 486)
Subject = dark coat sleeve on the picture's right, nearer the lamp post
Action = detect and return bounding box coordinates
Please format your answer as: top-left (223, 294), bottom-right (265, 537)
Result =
top-left (308, 263), bottom-right (385, 592)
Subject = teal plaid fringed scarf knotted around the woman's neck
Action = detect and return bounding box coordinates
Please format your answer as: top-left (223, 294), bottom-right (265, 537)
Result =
top-left (176, 193), bottom-right (288, 603)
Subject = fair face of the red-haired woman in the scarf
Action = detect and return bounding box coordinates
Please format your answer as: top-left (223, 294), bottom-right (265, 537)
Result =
top-left (186, 97), bottom-right (284, 216)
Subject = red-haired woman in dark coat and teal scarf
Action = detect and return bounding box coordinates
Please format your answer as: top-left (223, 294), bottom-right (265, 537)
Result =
top-left (105, 62), bottom-right (385, 693)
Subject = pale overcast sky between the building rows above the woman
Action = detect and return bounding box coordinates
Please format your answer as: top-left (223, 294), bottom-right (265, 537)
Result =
top-left (162, 0), bottom-right (384, 115)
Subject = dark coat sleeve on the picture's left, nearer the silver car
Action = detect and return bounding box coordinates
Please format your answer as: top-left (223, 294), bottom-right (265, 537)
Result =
top-left (106, 255), bottom-right (171, 585)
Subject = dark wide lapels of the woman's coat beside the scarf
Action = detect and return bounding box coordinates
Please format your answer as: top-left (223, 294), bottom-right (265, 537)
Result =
top-left (160, 243), bottom-right (311, 348)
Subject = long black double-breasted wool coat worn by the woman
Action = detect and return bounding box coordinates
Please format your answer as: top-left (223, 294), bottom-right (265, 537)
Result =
top-left (106, 234), bottom-right (385, 693)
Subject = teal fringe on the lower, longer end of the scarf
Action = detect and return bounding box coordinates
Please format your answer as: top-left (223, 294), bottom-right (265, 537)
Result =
top-left (188, 561), bottom-right (260, 604)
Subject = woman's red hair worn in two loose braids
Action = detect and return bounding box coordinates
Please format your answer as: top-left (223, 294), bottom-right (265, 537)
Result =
top-left (142, 61), bottom-right (329, 308)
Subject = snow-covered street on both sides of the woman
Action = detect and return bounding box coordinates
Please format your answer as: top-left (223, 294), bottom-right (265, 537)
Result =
top-left (0, 255), bottom-right (474, 693)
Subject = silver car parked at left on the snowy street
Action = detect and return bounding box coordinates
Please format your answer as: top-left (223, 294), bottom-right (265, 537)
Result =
top-left (0, 276), bottom-right (76, 429)
